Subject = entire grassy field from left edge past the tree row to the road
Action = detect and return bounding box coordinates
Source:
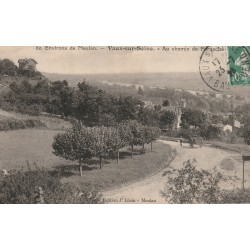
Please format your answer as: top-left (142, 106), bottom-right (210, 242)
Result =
top-left (0, 129), bottom-right (172, 190)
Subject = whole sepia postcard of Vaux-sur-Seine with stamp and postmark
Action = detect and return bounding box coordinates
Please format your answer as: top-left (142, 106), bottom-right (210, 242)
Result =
top-left (0, 46), bottom-right (250, 204)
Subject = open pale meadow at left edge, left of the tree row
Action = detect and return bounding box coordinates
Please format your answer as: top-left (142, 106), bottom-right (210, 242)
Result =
top-left (0, 129), bottom-right (67, 170)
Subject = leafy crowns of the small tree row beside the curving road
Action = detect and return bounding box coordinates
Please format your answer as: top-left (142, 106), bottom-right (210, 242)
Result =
top-left (52, 120), bottom-right (160, 168)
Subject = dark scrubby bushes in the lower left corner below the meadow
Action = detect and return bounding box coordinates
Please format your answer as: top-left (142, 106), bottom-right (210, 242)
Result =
top-left (0, 169), bottom-right (101, 204)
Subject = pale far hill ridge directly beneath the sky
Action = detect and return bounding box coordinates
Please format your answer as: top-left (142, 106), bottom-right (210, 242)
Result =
top-left (43, 71), bottom-right (250, 97)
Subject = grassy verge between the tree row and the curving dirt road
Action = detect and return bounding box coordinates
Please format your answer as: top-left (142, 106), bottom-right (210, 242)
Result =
top-left (61, 142), bottom-right (172, 191)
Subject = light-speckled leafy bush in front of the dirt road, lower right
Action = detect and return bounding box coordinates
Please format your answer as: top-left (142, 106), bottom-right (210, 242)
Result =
top-left (162, 159), bottom-right (228, 204)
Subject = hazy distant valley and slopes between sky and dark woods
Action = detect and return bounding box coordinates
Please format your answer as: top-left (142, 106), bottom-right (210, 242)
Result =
top-left (44, 73), bottom-right (250, 113)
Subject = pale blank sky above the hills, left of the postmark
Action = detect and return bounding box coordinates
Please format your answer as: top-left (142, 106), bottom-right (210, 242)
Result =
top-left (0, 46), bottom-right (202, 74)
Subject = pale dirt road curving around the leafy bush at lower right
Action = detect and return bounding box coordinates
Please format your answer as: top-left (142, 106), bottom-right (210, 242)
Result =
top-left (103, 140), bottom-right (250, 204)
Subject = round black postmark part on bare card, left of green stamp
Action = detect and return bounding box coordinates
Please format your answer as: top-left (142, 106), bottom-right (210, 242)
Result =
top-left (199, 46), bottom-right (229, 92)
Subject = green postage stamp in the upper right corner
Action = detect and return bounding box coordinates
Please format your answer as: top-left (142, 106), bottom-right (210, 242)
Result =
top-left (227, 46), bottom-right (250, 86)
